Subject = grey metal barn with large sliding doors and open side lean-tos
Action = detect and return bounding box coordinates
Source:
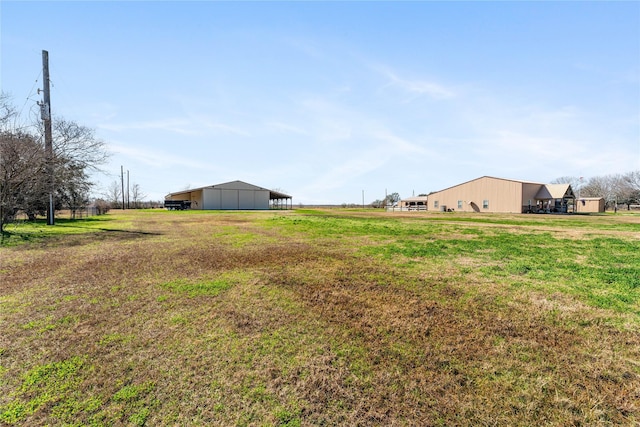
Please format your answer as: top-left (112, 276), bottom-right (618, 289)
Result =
top-left (165, 181), bottom-right (292, 210)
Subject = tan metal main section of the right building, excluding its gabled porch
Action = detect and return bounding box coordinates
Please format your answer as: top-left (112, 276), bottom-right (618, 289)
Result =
top-left (429, 177), bottom-right (540, 213)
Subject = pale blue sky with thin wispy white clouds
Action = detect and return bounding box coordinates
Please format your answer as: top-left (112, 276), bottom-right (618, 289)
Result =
top-left (0, 0), bottom-right (640, 205)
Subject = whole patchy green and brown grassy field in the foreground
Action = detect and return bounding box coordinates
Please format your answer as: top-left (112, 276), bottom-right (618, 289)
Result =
top-left (0, 209), bottom-right (640, 426)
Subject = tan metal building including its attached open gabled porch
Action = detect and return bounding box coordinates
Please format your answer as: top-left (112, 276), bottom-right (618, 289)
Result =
top-left (428, 176), bottom-right (575, 213)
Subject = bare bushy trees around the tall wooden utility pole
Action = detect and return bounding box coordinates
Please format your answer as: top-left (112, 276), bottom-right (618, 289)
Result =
top-left (0, 92), bottom-right (108, 232)
